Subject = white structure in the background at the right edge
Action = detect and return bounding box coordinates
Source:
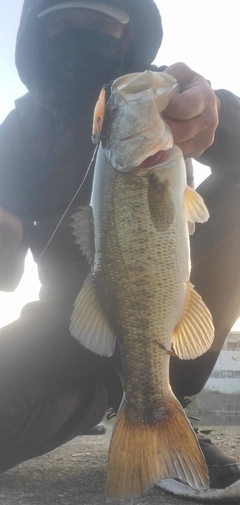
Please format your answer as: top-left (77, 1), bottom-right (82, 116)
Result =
top-left (205, 331), bottom-right (240, 394)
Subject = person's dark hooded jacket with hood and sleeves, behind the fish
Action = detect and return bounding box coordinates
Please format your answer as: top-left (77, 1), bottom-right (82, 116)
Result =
top-left (0, 0), bottom-right (240, 303)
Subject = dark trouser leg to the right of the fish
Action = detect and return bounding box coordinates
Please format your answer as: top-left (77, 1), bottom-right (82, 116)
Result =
top-left (170, 173), bottom-right (240, 400)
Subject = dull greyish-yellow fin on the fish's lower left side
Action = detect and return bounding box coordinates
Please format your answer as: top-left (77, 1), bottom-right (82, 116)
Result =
top-left (70, 273), bottom-right (116, 356)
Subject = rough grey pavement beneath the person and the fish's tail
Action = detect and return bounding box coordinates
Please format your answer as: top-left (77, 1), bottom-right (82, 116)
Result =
top-left (0, 426), bottom-right (240, 505)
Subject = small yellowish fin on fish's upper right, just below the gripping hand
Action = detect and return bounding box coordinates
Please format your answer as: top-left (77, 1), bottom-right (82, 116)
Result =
top-left (185, 186), bottom-right (209, 234)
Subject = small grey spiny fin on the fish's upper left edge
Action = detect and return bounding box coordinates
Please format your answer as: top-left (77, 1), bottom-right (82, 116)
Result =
top-left (71, 205), bottom-right (95, 265)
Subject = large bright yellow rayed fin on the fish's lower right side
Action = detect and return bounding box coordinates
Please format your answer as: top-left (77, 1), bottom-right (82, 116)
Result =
top-left (172, 282), bottom-right (214, 359)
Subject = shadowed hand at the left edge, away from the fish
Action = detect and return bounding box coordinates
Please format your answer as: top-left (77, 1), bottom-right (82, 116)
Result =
top-left (0, 207), bottom-right (22, 267)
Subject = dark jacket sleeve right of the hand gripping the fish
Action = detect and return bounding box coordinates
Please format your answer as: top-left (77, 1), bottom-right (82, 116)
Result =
top-left (197, 89), bottom-right (240, 174)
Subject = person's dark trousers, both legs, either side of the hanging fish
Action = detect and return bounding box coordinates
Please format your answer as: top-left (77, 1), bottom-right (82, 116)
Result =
top-left (0, 174), bottom-right (240, 472)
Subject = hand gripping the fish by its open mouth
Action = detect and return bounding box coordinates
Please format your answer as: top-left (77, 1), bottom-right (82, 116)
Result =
top-left (163, 63), bottom-right (220, 158)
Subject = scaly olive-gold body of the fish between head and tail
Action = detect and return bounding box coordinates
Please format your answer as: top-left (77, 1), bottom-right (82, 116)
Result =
top-left (109, 170), bottom-right (185, 406)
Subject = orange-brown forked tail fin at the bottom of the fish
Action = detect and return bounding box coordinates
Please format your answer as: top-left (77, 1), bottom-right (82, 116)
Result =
top-left (106, 396), bottom-right (209, 501)
